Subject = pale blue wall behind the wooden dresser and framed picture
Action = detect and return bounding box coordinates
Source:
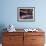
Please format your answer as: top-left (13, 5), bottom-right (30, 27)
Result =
top-left (0, 0), bottom-right (46, 43)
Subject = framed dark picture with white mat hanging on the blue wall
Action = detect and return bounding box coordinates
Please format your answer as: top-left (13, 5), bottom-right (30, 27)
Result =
top-left (17, 7), bottom-right (35, 22)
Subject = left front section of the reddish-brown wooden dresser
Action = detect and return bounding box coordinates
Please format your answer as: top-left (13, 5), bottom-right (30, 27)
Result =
top-left (3, 33), bottom-right (23, 46)
